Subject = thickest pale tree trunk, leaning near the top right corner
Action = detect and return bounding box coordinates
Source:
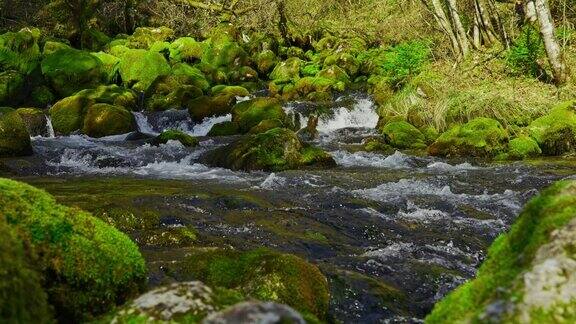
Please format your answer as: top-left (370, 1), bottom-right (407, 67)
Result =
top-left (534, 0), bottom-right (567, 85)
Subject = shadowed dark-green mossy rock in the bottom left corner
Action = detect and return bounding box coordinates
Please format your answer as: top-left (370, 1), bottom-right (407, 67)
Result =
top-left (0, 217), bottom-right (53, 323)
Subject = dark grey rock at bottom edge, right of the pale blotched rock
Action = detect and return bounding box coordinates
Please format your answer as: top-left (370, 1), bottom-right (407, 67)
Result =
top-left (202, 302), bottom-right (306, 324)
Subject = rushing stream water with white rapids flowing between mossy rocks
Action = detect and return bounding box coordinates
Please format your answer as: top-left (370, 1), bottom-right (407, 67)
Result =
top-left (0, 94), bottom-right (576, 322)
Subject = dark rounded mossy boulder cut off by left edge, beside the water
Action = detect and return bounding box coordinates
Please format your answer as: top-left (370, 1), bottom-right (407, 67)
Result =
top-left (0, 108), bottom-right (32, 157)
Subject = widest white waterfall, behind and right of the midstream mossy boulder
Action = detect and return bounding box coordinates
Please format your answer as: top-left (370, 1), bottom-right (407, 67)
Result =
top-left (318, 98), bottom-right (378, 133)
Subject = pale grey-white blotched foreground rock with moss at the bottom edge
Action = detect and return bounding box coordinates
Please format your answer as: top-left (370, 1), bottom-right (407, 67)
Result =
top-left (99, 281), bottom-right (243, 323)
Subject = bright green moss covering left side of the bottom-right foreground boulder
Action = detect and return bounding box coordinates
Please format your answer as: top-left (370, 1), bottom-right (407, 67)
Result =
top-left (426, 181), bottom-right (576, 323)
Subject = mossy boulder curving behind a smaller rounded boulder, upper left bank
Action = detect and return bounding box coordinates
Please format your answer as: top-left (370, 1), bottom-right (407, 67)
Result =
top-left (50, 85), bottom-right (137, 135)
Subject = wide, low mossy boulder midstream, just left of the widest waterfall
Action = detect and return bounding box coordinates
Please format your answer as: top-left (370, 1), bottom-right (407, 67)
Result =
top-left (203, 128), bottom-right (336, 171)
